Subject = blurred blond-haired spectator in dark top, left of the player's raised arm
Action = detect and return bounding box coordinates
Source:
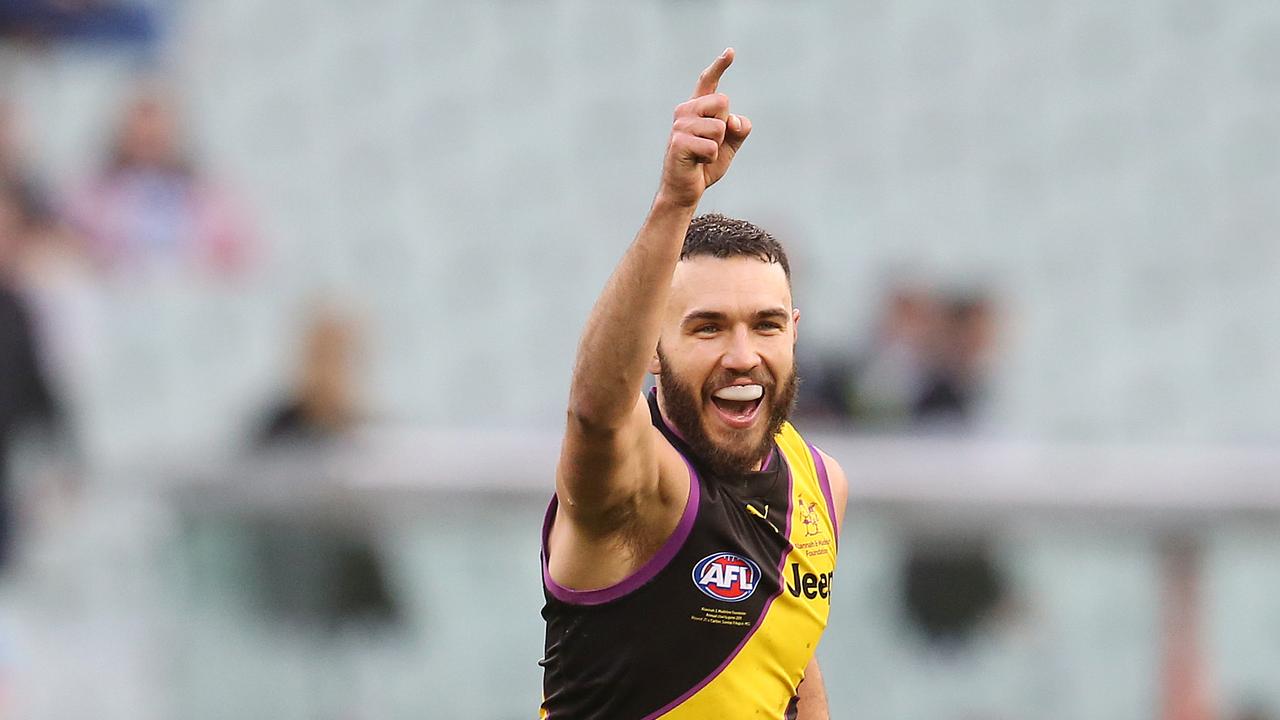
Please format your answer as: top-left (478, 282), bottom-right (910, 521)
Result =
top-left (259, 310), bottom-right (358, 446)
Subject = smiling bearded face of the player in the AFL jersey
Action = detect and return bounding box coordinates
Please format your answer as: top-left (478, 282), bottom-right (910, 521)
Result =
top-left (650, 256), bottom-right (800, 471)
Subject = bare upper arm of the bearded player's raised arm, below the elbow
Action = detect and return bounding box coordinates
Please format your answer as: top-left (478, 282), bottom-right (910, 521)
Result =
top-left (556, 396), bottom-right (658, 524)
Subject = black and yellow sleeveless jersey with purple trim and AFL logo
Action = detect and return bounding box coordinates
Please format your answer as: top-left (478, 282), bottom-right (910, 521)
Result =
top-left (539, 395), bottom-right (837, 720)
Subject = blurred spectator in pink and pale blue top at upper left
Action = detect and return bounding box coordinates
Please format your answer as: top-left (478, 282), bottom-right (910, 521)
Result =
top-left (70, 91), bottom-right (253, 274)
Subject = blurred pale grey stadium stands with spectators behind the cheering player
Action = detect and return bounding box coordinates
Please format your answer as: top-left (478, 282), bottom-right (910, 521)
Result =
top-left (0, 0), bottom-right (1280, 720)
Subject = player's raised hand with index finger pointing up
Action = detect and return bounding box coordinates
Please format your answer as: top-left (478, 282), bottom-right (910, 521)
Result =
top-left (658, 47), bottom-right (751, 208)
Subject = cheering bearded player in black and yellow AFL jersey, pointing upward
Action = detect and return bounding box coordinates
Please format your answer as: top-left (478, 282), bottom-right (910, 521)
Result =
top-left (541, 49), bottom-right (847, 720)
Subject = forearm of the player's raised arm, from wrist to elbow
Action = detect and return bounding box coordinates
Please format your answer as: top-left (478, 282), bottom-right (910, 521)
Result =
top-left (570, 195), bottom-right (695, 428)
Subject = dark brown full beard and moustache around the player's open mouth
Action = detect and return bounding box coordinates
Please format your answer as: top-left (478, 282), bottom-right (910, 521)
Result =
top-left (658, 346), bottom-right (800, 475)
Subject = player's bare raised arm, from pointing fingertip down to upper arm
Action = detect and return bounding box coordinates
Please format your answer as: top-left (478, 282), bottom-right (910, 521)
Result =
top-left (556, 49), bottom-right (751, 529)
